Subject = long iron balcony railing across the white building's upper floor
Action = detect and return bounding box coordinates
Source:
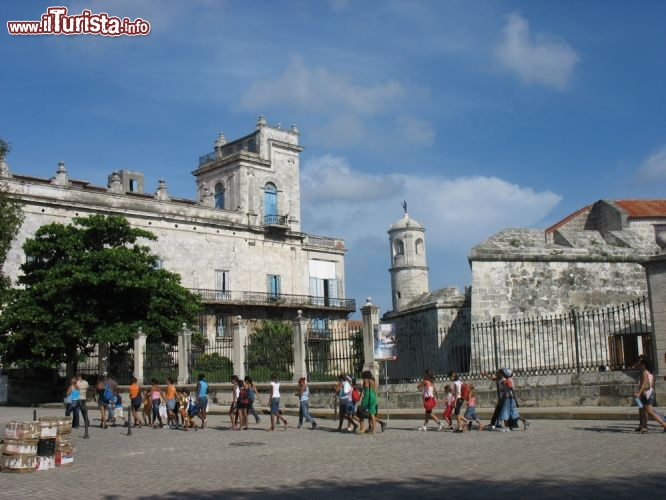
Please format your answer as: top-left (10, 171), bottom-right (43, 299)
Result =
top-left (191, 288), bottom-right (356, 311)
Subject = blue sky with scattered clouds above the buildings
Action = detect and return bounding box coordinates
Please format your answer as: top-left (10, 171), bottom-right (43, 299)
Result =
top-left (0, 0), bottom-right (666, 313)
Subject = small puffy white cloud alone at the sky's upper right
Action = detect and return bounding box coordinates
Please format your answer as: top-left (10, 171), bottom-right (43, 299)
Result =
top-left (496, 13), bottom-right (579, 90)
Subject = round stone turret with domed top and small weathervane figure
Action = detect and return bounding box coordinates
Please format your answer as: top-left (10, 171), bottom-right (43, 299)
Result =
top-left (388, 202), bottom-right (428, 311)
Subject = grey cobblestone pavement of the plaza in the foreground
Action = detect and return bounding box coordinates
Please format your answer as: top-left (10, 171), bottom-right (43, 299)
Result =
top-left (0, 407), bottom-right (666, 500)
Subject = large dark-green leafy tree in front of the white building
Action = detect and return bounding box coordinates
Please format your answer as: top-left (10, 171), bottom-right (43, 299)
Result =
top-left (0, 215), bottom-right (201, 369)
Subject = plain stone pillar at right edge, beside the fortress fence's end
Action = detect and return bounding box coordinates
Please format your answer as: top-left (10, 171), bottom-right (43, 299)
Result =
top-left (642, 251), bottom-right (666, 379)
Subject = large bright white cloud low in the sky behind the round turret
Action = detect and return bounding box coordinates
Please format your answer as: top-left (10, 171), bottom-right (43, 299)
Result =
top-left (301, 155), bottom-right (561, 249)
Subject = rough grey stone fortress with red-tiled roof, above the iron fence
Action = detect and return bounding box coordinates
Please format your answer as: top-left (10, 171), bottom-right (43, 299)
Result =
top-left (469, 200), bottom-right (666, 323)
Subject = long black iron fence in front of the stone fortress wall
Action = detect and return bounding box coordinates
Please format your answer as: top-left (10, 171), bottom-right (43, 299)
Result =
top-left (388, 297), bottom-right (653, 382)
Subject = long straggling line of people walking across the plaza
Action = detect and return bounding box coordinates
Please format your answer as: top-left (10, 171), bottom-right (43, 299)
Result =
top-left (65, 356), bottom-right (666, 434)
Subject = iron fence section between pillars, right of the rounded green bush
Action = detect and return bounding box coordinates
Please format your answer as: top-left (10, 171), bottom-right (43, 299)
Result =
top-left (305, 329), bottom-right (364, 382)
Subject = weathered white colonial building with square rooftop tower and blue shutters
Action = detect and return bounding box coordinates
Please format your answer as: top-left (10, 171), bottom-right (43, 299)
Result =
top-left (0, 117), bottom-right (355, 340)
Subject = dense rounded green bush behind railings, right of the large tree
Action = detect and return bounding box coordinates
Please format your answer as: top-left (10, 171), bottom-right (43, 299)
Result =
top-left (247, 320), bottom-right (294, 381)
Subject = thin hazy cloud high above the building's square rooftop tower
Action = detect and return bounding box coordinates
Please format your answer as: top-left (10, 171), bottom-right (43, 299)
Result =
top-left (240, 56), bottom-right (406, 113)
